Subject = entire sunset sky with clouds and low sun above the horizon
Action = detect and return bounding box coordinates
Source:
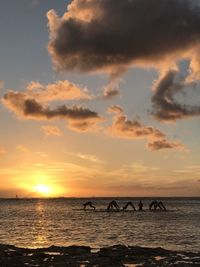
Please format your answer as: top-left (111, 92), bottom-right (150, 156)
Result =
top-left (0, 0), bottom-right (200, 197)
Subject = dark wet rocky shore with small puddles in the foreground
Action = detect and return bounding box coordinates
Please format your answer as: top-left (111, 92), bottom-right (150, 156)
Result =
top-left (0, 245), bottom-right (200, 267)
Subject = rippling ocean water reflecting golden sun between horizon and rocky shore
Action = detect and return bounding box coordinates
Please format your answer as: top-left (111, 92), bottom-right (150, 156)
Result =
top-left (0, 198), bottom-right (200, 252)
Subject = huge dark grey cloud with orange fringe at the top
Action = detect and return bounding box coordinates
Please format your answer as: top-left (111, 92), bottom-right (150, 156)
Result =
top-left (47, 0), bottom-right (200, 73)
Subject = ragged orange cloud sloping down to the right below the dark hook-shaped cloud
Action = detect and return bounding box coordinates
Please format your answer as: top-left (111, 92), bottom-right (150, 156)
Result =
top-left (107, 106), bottom-right (184, 151)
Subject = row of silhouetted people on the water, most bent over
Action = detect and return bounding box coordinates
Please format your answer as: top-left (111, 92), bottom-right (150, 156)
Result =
top-left (83, 200), bottom-right (167, 211)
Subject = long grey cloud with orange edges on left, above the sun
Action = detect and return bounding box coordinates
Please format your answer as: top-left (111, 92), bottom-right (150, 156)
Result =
top-left (2, 91), bottom-right (104, 132)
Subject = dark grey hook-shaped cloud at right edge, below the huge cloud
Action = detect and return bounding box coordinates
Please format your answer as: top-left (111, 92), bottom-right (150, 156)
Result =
top-left (152, 69), bottom-right (200, 121)
